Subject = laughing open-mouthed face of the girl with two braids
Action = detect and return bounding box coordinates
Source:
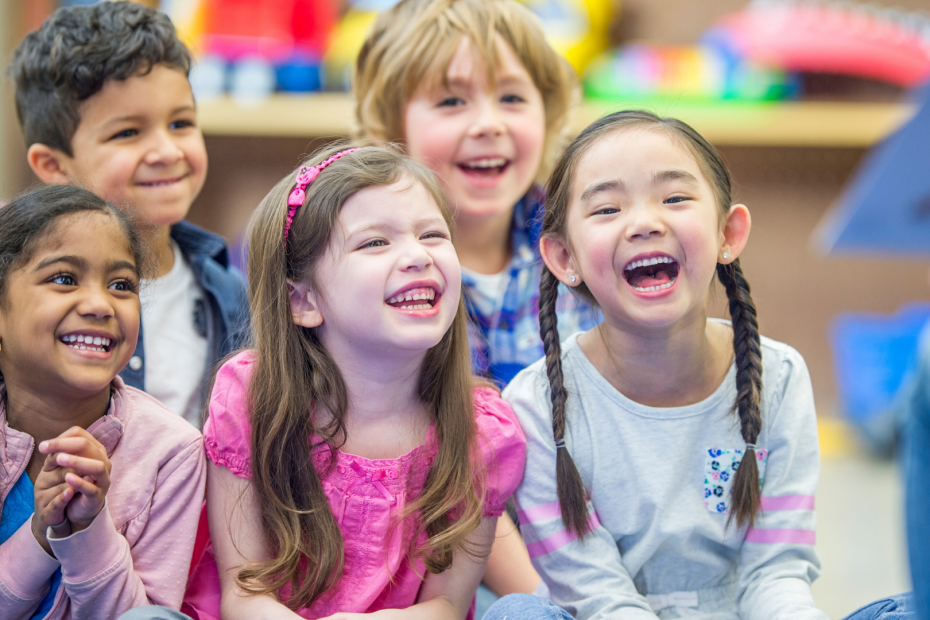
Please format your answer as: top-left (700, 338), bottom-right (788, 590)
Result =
top-left (566, 128), bottom-right (726, 327)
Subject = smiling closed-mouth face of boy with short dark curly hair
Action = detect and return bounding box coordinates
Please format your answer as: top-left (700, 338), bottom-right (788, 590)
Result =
top-left (59, 65), bottom-right (207, 226)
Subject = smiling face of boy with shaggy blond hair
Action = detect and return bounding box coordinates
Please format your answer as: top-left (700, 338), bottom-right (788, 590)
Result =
top-left (405, 35), bottom-right (546, 228)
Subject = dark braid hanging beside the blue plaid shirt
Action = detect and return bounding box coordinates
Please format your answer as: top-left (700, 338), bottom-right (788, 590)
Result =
top-left (539, 267), bottom-right (591, 537)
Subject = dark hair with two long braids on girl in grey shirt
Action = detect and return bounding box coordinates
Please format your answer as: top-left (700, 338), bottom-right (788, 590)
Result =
top-left (539, 110), bottom-right (762, 536)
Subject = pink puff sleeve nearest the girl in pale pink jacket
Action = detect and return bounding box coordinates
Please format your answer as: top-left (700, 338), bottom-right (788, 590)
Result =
top-left (203, 351), bottom-right (255, 478)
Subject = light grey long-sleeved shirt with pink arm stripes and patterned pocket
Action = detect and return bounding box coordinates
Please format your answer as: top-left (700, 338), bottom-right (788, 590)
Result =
top-left (504, 335), bottom-right (827, 620)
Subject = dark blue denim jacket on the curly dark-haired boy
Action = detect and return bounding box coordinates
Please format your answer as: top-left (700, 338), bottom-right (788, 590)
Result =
top-left (120, 220), bottom-right (249, 404)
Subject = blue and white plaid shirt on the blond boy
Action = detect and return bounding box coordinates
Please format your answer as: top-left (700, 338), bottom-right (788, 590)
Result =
top-left (462, 186), bottom-right (601, 387)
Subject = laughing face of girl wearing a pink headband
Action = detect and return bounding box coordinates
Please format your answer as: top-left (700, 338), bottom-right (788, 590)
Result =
top-left (301, 178), bottom-right (461, 357)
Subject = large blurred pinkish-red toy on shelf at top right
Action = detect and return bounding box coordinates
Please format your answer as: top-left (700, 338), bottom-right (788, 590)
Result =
top-left (704, 0), bottom-right (930, 87)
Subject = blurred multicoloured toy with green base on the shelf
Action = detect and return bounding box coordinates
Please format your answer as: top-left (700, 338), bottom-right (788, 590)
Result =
top-left (584, 44), bottom-right (798, 101)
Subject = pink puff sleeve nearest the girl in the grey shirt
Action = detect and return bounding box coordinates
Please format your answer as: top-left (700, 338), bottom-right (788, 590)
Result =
top-left (474, 387), bottom-right (526, 517)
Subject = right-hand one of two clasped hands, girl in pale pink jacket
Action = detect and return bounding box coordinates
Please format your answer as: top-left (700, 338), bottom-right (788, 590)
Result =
top-left (39, 426), bottom-right (110, 533)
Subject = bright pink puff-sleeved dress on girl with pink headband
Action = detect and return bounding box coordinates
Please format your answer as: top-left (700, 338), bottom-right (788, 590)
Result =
top-left (183, 351), bottom-right (526, 620)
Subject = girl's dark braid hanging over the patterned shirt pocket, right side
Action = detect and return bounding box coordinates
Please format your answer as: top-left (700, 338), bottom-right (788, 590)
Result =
top-left (717, 259), bottom-right (762, 527)
